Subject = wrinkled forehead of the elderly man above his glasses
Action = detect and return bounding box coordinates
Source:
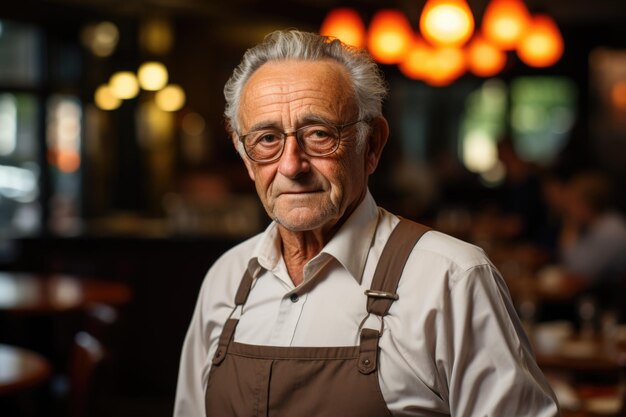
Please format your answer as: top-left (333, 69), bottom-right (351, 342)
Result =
top-left (239, 60), bottom-right (356, 128)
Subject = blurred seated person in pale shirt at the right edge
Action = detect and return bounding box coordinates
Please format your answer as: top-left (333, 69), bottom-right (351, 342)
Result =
top-left (559, 172), bottom-right (626, 316)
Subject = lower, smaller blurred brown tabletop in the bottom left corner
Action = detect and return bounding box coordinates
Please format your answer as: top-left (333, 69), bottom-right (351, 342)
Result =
top-left (0, 344), bottom-right (50, 395)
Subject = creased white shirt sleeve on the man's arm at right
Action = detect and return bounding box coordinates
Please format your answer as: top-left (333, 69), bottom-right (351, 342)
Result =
top-left (443, 264), bottom-right (559, 417)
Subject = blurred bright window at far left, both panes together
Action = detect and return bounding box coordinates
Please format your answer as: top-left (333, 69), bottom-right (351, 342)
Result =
top-left (0, 20), bottom-right (83, 238)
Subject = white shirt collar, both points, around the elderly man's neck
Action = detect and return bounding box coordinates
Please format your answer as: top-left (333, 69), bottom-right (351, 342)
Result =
top-left (248, 190), bottom-right (378, 283)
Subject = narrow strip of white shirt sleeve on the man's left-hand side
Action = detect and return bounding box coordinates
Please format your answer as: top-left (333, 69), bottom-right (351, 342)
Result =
top-left (174, 278), bottom-right (208, 417)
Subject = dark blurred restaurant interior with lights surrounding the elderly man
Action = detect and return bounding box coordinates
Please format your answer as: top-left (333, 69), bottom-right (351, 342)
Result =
top-left (0, 0), bottom-right (626, 417)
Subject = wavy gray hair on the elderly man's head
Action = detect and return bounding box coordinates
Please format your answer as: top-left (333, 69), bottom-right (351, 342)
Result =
top-left (224, 30), bottom-right (387, 153)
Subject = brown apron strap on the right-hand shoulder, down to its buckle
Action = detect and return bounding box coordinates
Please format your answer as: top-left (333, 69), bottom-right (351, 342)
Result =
top-left (365, 218), bottom-right (430, 317)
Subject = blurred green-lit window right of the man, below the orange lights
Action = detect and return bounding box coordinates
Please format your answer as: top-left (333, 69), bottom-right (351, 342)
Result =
top-left (459, 76), bottom-right (577, 186)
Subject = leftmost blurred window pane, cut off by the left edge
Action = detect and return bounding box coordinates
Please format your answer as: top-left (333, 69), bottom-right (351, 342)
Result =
top-left (0, 20), bottom-right (42, 237)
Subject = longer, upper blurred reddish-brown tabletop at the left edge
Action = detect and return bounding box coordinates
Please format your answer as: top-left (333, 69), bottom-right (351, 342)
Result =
top-left (0, 272), bottom-right (131, 314)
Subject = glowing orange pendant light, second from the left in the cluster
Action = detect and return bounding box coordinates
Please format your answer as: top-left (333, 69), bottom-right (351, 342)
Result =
top-left (367, 9), bottom-right (414, 64)
